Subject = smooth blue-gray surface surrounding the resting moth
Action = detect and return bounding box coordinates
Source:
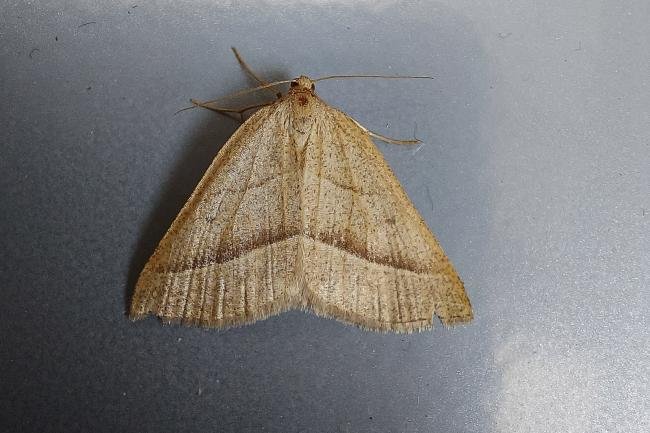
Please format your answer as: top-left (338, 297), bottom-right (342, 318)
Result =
top-left (0, 0), bottom-right (650, 432)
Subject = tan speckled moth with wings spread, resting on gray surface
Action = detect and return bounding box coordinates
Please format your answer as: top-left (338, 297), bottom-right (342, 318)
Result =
top-left (130, 52), bottom-right (472, 332)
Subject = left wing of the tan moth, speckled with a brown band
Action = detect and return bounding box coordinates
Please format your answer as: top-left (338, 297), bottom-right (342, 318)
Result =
top-left (130, 106), bottom-right (300, 327)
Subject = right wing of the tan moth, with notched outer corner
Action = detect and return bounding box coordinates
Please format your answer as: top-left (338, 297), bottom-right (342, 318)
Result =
top-left (302, 106), bottom-right (472, 332)
